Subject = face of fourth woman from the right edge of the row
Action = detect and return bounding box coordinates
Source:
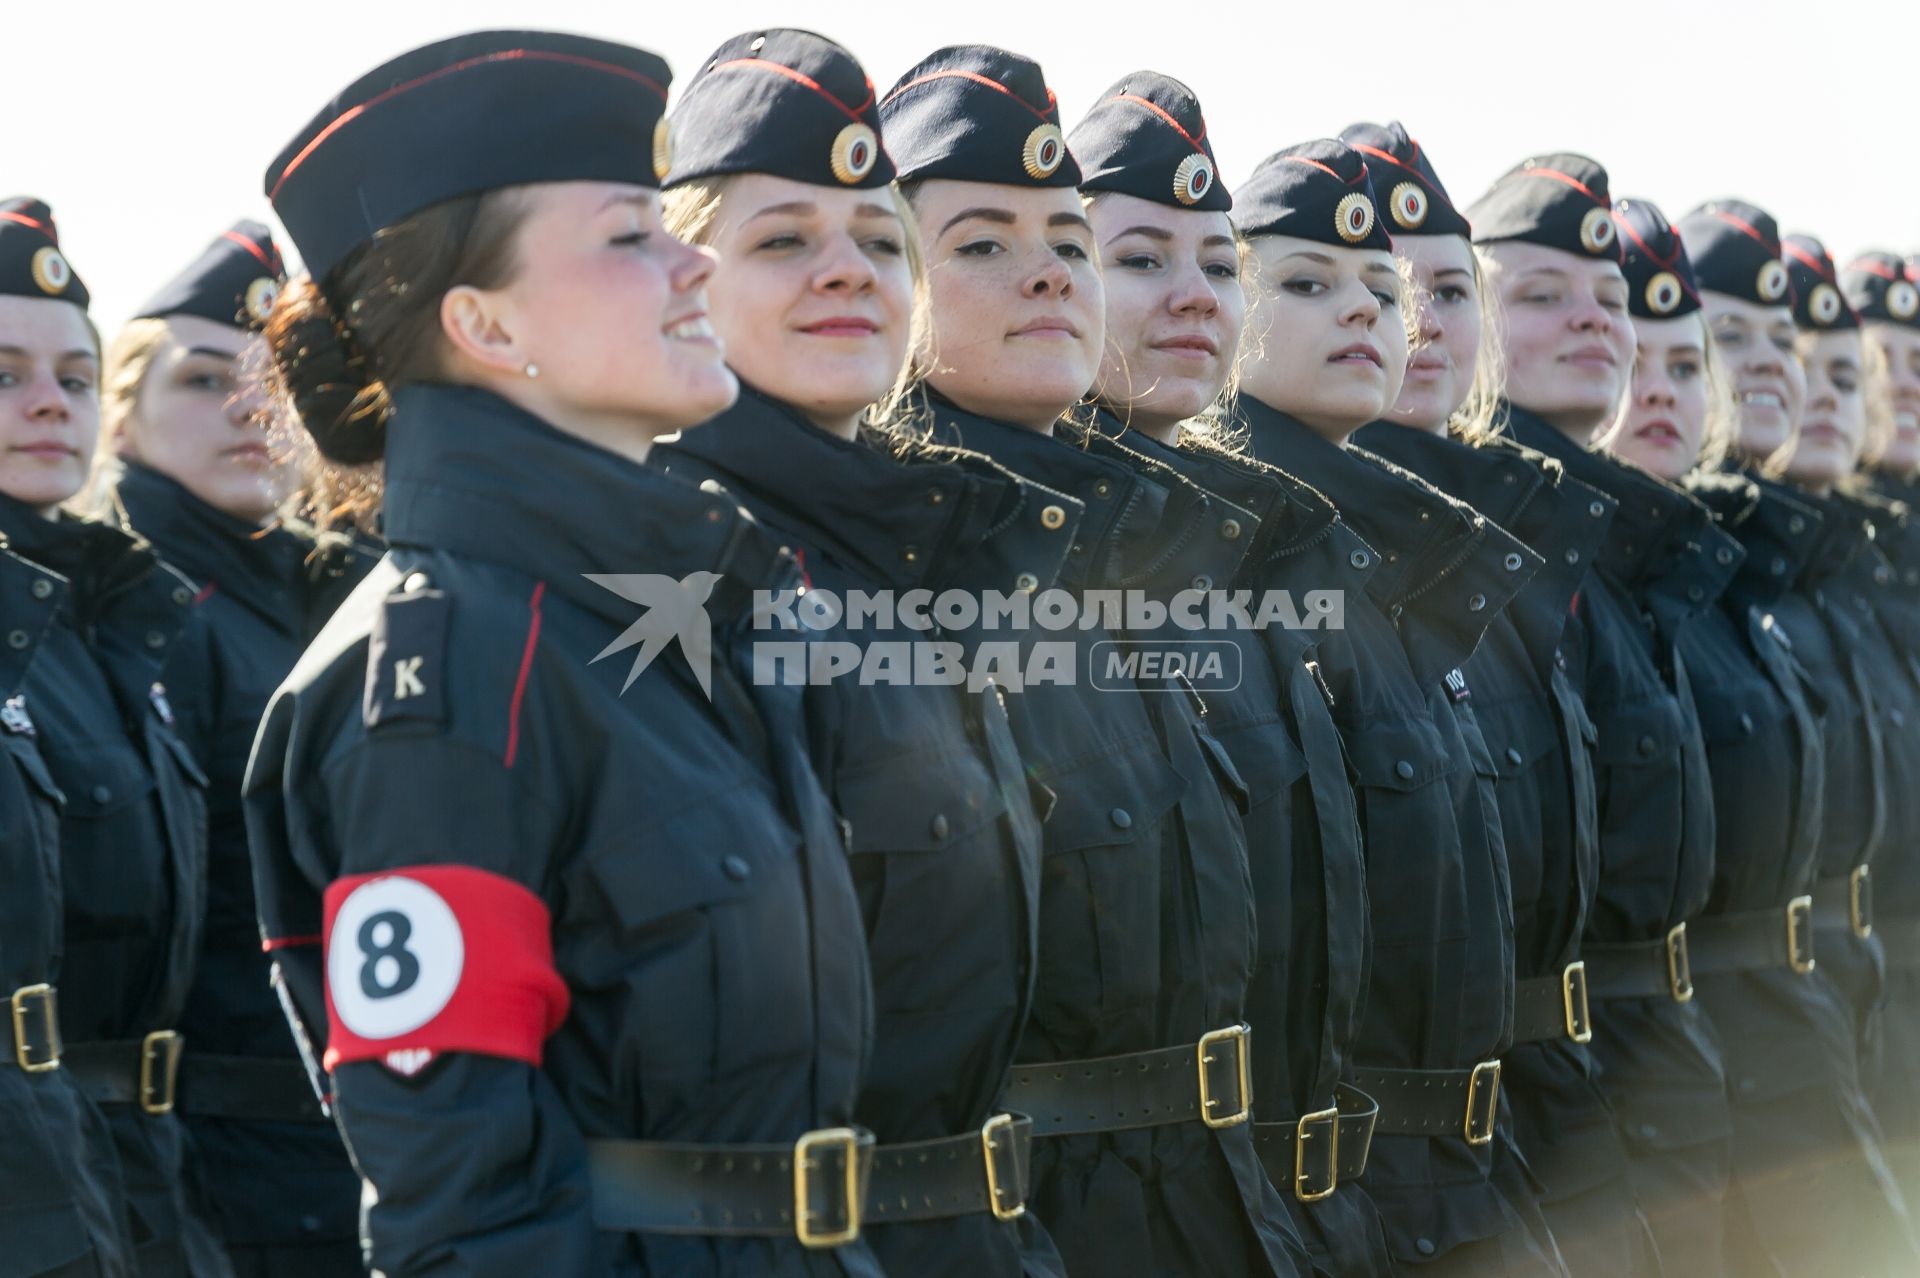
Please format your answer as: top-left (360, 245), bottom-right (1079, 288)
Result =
top-left (1599, 313), bottom-right (1709, 480)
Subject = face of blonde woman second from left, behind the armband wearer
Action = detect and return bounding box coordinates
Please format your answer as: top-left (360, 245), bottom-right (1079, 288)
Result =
top-left (108, 315), bottom-right (292, 520)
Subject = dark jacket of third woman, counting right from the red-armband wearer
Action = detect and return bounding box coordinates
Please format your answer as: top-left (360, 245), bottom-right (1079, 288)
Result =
top-left (910, 395), bottom-right (1306, 1274)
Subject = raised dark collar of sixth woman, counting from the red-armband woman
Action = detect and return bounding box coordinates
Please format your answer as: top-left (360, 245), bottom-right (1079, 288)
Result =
top-left (1356, 422), bottom-right (1619, 681)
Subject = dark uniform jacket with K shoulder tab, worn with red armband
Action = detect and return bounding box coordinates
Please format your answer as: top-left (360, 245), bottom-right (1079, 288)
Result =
top-left (246, 386), bottom-right (879, 1278)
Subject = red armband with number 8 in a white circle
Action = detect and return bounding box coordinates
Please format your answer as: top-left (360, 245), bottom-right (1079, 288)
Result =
top-left (323, 865), bottom-right (568, 1069)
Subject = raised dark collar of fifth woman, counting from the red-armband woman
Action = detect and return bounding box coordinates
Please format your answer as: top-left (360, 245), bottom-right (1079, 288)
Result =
top-left (1240, 395), bottom-right (1542, 683)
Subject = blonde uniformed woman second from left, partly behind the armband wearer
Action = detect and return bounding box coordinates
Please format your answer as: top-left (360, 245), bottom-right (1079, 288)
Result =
top-left (94, 223), bottom-right (369, 1278)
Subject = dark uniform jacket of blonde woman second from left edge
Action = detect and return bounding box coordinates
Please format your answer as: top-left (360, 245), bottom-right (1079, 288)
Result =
top-left (117, 454), bottom-right (374, 1245)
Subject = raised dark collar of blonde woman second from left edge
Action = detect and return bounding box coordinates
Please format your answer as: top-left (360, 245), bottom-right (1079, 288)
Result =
top-left (115, 462), bottom-right (311, 633)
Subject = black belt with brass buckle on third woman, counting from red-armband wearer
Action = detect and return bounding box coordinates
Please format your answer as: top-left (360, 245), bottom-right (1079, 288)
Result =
top-left (1006, 1025), bottom-right (1254, 1136)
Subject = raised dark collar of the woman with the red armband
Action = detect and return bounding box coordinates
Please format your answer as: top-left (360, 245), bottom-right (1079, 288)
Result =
top-left (382, 384), bottom-right (795, 622)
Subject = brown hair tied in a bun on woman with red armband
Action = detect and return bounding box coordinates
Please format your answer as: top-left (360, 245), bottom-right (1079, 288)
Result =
top-left (267, 186), bottom-right (526, 526)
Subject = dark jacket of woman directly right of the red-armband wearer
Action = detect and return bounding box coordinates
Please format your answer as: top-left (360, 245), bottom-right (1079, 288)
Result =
top-left (649, 390), bottom-right (1079, 1278)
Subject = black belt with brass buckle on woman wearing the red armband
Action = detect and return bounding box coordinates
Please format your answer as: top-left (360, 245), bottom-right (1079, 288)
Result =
top-left (588, 1126), bottom-right (874, 1247)
